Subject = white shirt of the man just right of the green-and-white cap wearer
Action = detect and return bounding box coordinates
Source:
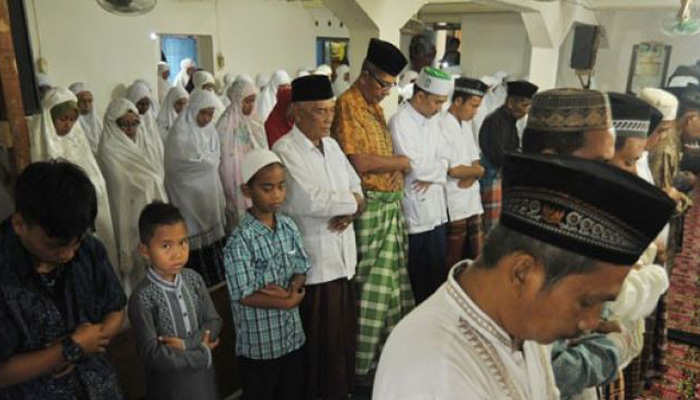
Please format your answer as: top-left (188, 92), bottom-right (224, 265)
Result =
top-left (440, 112), bottom-right (484, 221)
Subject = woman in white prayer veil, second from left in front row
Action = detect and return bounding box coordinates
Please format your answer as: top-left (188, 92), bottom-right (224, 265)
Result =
top-left (97, 98), bottom-right (168, 296)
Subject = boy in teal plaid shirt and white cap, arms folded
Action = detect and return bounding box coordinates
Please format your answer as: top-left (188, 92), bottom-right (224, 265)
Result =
top-left (224, 149), bottom-right (309, 400)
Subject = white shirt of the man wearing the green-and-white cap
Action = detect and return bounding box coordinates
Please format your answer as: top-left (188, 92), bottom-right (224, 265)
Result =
top-left (389, 102), bottom-right (449, 234)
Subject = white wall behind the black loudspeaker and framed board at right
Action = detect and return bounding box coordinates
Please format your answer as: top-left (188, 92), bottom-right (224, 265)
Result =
top-left (558, 10), bottom-right (700, 92)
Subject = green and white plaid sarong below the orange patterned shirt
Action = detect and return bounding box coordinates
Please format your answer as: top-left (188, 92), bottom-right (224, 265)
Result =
top-left (354, 192), bottom-right (415, 383)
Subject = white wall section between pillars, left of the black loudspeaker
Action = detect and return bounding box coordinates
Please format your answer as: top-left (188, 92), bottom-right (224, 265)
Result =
top-left (461, 13), bottom-right (530, 78)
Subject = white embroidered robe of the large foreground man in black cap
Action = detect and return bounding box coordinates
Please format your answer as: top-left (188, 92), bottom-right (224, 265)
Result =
top-left (372, 262), bottom-right (559, 400)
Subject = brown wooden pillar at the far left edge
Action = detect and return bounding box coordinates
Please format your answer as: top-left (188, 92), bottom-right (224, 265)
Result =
top-left (0, 0), bottom-right (29, 193)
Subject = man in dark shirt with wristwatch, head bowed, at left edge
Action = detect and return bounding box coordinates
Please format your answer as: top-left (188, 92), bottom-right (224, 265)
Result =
top-left (0, 161), bottom-right (126, 400)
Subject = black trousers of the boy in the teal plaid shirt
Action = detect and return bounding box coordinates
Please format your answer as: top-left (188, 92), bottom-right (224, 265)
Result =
top-left (238, 348), bottom-right (304, 400)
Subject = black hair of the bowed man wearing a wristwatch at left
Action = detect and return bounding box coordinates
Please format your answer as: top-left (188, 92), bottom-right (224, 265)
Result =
top-left (15, 159), bottom-right (97, 242)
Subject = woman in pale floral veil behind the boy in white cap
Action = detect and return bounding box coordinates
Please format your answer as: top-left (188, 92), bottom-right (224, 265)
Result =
top-left (216, 81), bottom-right (268, 228)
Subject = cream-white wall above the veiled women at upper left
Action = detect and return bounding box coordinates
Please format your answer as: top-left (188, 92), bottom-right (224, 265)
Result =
top-left (27, 0), bottom-right (349, 114)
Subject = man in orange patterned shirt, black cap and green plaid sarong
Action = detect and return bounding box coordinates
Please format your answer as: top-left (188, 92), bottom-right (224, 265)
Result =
top-left (332, 39), bottom-right (414, 386)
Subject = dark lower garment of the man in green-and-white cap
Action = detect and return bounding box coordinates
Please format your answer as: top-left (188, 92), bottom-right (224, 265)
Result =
top-left (408, 224), bottom-right (447, 305)
